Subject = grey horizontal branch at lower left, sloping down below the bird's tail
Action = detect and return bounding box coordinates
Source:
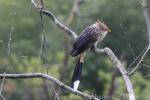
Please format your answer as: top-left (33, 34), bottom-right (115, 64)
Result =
top-left (0, 73), bottom-right (99, 100)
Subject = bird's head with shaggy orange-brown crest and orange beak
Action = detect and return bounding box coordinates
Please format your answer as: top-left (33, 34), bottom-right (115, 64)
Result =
top-left (93, 20), bottom-right (111, 33)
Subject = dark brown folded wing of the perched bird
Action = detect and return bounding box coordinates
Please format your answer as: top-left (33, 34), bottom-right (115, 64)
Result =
top-left (71, 26), bottom-right (99, 56)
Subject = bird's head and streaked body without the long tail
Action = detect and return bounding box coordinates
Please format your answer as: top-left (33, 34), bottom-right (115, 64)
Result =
top-left (71, 21), bottom-right (110, 56)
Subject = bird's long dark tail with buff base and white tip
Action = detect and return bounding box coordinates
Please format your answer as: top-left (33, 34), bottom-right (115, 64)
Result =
top-left (71, 52), bottom-right (85, 91)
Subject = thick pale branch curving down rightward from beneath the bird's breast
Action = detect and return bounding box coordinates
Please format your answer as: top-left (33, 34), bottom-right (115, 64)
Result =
top-left (95, 47), bottom-right (135, 100)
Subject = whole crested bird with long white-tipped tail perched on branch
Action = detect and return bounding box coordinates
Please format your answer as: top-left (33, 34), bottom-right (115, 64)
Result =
top-left (70, 20), bottom-right (111, 90)
